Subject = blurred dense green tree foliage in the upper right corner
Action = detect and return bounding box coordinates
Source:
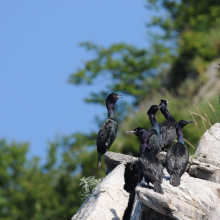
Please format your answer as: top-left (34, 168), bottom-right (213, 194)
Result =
top-left (147, 0), bottom-right (220, 90)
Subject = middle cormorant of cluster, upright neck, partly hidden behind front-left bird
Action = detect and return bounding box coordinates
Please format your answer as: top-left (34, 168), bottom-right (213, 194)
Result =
top-left (147, 105), bottom-right (162, 156)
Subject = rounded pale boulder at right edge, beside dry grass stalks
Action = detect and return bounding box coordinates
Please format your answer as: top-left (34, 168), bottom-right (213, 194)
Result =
top-left (195, 123), bottom-right (220, 167)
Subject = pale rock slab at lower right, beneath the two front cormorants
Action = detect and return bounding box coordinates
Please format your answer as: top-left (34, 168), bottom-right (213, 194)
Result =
top-left (131, 169), bottom-right (220, 220)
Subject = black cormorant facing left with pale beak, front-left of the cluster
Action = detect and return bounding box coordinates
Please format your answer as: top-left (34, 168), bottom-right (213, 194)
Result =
top-left (127, 127), bottom-right (164, 194)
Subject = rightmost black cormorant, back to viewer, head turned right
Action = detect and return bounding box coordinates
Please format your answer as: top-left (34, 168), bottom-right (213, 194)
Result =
top-left (166, 120), bottom-right (194, 186)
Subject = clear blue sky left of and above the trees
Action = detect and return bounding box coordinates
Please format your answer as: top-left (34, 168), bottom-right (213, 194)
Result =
top-left (0, 0), bottom-right (150, 159)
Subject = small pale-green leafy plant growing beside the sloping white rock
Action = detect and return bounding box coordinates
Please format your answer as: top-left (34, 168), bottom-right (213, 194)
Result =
top-left (80, 176), bottom-right (102, 201)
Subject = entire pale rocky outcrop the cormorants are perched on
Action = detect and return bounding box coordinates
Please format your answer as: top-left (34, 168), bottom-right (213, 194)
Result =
top-left (72, 123), bottom-right (220, 220)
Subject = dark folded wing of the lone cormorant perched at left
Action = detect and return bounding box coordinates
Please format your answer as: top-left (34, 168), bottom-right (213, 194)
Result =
top-left (96, 118), bottom-right (113, 154)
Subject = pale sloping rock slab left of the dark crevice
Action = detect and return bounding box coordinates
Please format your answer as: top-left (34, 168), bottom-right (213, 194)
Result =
top-left (72, 164), bottom-right (129, 220)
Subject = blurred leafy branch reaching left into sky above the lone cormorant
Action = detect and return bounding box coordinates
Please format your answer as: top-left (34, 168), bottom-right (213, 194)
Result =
top-left (69, 42), bottom-right (169, 106)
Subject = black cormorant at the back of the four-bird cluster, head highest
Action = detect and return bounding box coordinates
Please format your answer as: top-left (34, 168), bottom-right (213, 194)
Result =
top-left (159, 99), bottom-right (177, 150)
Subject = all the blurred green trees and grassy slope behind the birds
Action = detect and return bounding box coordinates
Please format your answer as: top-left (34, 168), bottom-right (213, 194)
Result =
top-left (0, 0), bottom-right (220, 220)
